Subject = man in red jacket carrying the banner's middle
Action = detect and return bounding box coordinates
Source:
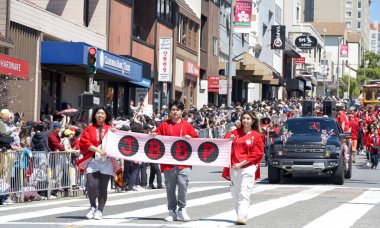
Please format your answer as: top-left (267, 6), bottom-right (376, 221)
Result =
top-left (152, 100), bottom-right (199, 222)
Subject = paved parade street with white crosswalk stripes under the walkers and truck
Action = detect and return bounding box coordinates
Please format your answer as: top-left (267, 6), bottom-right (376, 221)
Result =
top-left (0, 153), bottom-right (380, 228)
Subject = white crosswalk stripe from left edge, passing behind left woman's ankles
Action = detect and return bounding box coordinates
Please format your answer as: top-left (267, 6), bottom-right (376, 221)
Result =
top-left (0, 186), bottom-right (226, 222)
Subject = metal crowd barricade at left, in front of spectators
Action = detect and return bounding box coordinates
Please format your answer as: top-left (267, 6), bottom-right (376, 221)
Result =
top-left (0, 151), bottom-right (85, 205)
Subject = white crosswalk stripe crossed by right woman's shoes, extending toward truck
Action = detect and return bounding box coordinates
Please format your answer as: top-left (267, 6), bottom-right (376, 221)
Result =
top-left (181, 187), bottom-right (334, 227)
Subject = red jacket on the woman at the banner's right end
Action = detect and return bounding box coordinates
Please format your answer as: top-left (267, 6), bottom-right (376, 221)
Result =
top-left (224, 128), bottom-right (264, 179)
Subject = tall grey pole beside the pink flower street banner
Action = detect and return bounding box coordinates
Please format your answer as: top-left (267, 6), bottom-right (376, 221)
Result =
top-left (227, 0), bottom-right (235, 107)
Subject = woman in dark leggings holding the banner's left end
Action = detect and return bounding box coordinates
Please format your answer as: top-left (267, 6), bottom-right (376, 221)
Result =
top-left (76, 106), bottom-right (120, 220)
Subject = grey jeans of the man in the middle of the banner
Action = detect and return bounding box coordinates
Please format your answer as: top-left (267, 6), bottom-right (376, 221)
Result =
top-left (164, 166), bottom-right (191, 211)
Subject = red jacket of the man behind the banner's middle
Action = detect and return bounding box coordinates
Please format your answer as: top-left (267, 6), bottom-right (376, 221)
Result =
top-left (156, 119), bottom-right (199, 172)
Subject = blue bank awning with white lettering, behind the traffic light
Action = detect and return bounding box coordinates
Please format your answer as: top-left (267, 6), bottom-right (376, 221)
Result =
top-left (41, 41), bottom-right (150, 87)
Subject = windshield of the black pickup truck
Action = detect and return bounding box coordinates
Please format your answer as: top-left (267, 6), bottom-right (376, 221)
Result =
top-left (285, 119), bottom-right (338, 135)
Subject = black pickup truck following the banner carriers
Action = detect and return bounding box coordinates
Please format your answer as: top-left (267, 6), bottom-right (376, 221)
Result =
top-left (268, 117), bottom-right (352, 185)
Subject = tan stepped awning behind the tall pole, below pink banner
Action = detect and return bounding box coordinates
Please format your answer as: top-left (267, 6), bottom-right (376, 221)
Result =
top-left (219, 52), bottom-right (278, 85)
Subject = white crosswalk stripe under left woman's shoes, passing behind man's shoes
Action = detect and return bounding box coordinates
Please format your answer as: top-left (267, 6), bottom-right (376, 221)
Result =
top-left (74, 185), bottom-right (279, 225)
